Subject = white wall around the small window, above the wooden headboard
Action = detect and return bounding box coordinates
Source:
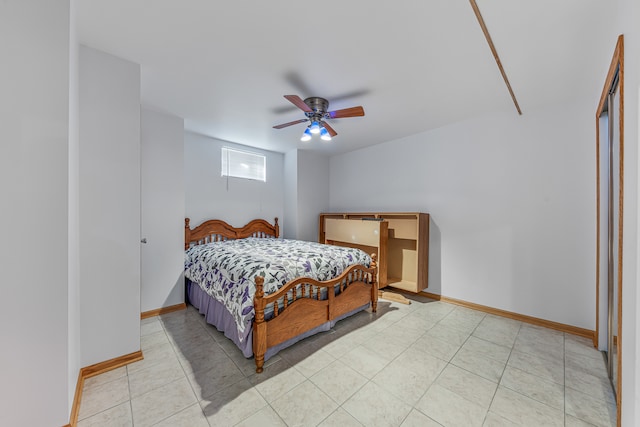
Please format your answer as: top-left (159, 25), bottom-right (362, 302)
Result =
top-left (184, 132), bottom-right (284, 230)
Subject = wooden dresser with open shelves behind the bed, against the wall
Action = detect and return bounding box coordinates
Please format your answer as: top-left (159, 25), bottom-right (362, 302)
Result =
top-left (318, 212), bottom-right (429, 292)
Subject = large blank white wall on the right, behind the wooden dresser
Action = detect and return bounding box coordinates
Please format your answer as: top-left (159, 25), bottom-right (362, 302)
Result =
top-left (330, 100), bottom-right (597, 329)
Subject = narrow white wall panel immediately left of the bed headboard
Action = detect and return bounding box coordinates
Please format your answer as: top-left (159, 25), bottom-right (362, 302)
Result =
top-left (140, 108), bottom-right (184, 312)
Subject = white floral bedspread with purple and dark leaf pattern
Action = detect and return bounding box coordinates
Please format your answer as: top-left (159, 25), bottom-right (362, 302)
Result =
top-left (185, 237), bottom-right (371, 342)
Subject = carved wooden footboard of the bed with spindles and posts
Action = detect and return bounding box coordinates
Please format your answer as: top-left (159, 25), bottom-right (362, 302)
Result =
top-left (253, 254), bottom-right (378, 373)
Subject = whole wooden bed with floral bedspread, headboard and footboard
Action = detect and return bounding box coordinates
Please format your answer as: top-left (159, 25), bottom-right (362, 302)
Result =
top-left (185, 218), bottom-right (378, 373)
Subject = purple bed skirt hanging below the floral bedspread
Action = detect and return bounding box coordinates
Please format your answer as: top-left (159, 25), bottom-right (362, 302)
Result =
top-left (185, 279), bottom-right (370, 361)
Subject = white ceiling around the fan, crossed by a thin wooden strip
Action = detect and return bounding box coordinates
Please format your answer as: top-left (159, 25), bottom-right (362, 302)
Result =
top-left (76, 0), bottom-right (615, 154)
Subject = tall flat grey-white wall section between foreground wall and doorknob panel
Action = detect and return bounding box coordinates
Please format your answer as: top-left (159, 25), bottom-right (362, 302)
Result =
top-left (79, 46), bottom-right (140, 366)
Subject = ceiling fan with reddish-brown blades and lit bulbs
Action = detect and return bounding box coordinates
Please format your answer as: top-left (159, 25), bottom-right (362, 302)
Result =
top-left (274, 95), bottom-right (364, 141)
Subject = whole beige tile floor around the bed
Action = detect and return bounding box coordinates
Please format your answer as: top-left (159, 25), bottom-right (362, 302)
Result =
top-left (78, 299), bottom-right (616, 427)
